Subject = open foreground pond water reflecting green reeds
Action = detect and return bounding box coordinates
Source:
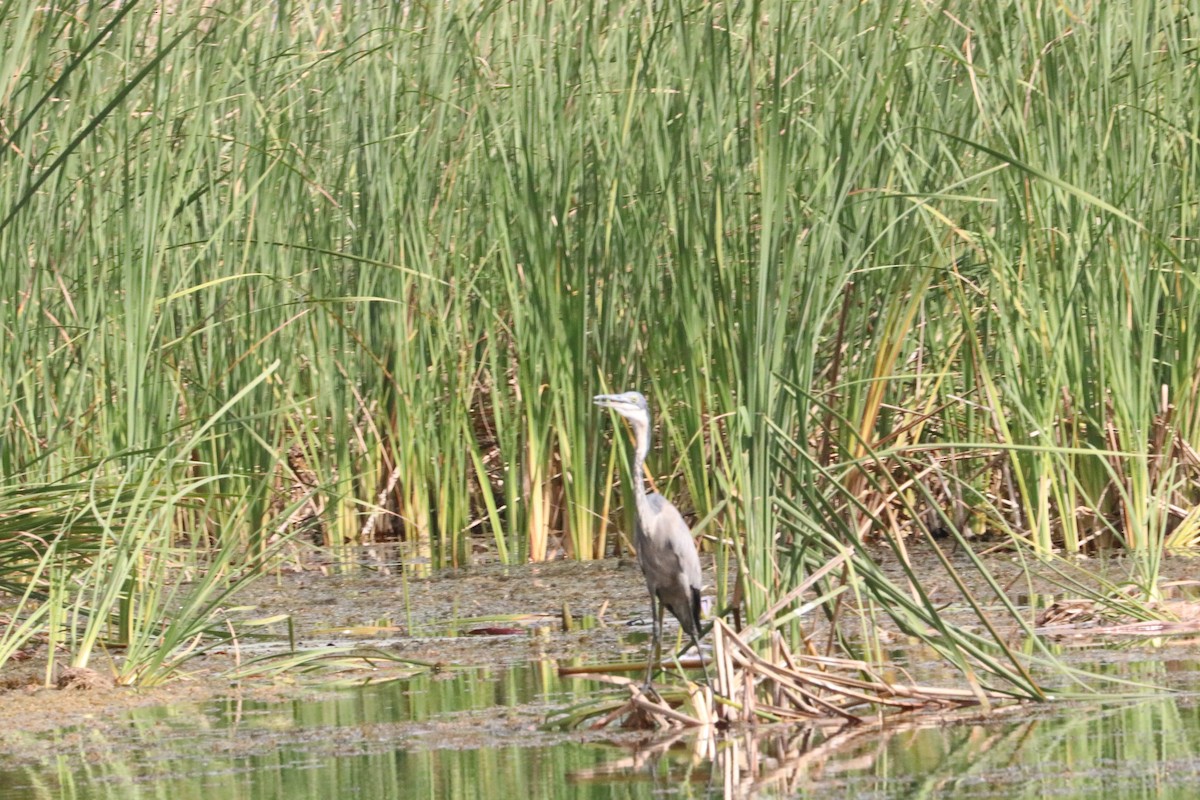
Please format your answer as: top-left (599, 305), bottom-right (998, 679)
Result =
top-left (0, 654), bottom-right (1200, 800)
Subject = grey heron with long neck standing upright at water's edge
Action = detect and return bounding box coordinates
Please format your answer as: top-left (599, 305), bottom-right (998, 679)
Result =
top-left (593, 392), bottom-right (708, 687)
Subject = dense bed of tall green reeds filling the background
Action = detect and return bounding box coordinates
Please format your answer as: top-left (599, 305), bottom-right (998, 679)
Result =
top-left (0, 0), bottom-right (1200, 680)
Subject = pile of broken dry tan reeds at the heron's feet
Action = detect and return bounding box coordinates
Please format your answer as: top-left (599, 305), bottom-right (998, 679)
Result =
top-left (568, 619), bottom-right (1014, 729)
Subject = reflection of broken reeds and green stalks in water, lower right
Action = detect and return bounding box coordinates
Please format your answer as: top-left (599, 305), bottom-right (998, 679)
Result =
top-left (571, 686), bottom-right (1200, 800)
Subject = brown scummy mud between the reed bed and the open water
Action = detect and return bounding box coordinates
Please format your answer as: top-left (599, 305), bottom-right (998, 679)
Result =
top-left (0, 553), bottom-right (1195, 751)
